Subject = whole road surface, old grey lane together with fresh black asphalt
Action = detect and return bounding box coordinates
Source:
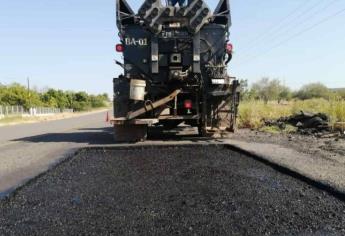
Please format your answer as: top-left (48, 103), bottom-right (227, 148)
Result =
top-left (0, 112), bottom-right (345, 235)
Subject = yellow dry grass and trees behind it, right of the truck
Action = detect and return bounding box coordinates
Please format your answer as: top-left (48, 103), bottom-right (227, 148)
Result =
top-left (238, 78), bottom-right (345, 132)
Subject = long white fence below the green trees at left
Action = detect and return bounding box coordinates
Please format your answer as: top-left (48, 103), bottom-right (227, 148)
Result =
top-left (0, 106), bottom-right (74, 119)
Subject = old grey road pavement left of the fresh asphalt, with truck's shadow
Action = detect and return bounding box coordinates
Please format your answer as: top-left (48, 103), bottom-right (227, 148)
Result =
top-left (0, 111), bottom-right (112, 197)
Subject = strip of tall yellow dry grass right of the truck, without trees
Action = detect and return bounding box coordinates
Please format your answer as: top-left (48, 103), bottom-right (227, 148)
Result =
top-left (238, 99), bottom-right (345, 129)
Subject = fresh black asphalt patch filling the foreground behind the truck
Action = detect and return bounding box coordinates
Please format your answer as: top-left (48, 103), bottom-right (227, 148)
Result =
top-left (0, 146), bottom-right (345, 235)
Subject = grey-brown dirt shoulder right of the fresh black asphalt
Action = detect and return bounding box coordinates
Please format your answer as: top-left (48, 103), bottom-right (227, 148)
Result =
top-left (224, 130), bottom-right (345, 194)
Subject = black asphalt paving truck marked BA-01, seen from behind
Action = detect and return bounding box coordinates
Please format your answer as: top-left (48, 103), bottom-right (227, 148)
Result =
top-left (112, 0), bottom-right (239, 142)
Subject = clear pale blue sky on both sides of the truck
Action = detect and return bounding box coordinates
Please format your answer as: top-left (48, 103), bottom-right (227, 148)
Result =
top-left (0, 0), bottom-right (345, 94)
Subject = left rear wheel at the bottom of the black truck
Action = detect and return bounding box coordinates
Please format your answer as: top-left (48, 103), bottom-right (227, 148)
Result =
top-left (114, 125), bottom-right (147, 143)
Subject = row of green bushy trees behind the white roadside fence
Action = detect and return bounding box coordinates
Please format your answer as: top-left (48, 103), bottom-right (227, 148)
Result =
top-left (0, 83), bottom-right (110, 111)
